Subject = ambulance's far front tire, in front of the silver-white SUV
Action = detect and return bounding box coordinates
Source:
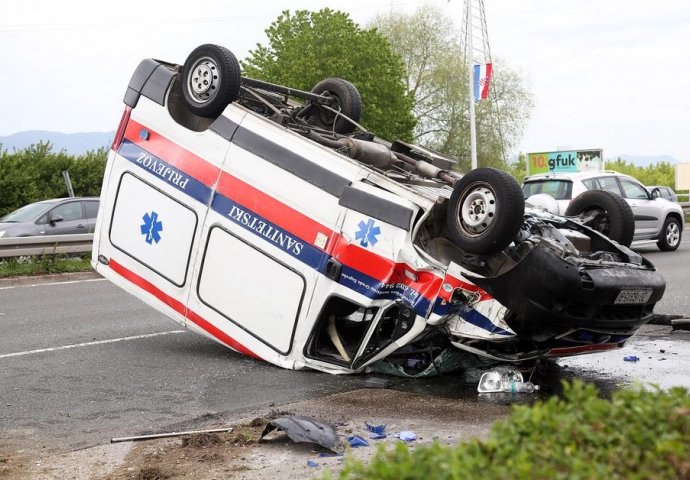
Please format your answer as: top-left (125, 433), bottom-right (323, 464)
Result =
top-left (565, 190), bottom-right (635, 247)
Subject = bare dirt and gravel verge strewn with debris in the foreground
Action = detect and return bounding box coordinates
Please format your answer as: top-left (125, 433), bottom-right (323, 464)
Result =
top-left (9, 389), bottom-right (509, 480)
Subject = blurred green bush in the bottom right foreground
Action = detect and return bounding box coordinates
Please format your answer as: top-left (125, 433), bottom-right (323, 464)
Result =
top-left (340, 382), bottom-right (690, 479)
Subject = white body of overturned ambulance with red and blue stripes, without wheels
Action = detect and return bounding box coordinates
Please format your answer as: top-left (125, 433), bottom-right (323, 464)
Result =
top-left (93, 46), bottom-right (660, 373)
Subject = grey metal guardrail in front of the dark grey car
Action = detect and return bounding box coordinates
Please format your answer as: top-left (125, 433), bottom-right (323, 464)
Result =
top-left (0, 233), bottom-right (93, 258)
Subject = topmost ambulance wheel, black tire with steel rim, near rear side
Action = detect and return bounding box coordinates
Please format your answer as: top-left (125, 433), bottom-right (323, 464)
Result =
top-left (178, 44), bottom-right (241, 118)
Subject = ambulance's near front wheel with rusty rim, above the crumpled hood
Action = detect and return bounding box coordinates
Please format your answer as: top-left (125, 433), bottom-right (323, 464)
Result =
top-left (447, 168), bottom-right (525, 255)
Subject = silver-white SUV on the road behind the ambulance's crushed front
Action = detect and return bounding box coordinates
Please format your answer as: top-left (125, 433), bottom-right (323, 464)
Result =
top-left (522, 170), bottom-right (685, 250)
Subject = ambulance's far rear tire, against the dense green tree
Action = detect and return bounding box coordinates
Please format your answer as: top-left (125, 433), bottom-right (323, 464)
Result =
top-left (311, 77), bottom-right (362, 134)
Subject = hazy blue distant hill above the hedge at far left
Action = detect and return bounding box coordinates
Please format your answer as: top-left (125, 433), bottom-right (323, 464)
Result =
top-left (0, 130), bottom-right (115, 155)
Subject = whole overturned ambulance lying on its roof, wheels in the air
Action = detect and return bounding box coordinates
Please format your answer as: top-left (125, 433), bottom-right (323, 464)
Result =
top-left (93, 45), bottom-right (665, 373)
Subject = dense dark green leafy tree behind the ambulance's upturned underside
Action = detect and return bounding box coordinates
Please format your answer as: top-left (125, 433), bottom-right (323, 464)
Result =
top-left (241, 8), bottom-right (414, 141)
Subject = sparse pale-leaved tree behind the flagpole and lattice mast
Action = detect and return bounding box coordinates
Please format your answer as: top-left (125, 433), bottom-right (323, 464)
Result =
top-left (372, 5), bottom-right (532, 170)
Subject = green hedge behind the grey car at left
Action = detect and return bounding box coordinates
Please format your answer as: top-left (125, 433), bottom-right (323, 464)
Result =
top-left (0, 143), bottom-right (108, 217)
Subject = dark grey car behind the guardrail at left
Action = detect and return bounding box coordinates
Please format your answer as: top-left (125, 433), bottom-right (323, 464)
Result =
top-left (0, 197), bottom-right (99, 238)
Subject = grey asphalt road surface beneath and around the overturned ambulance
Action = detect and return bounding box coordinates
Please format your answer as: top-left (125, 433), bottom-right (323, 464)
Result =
top-left (0, 234), bottom-right (690, 451)
